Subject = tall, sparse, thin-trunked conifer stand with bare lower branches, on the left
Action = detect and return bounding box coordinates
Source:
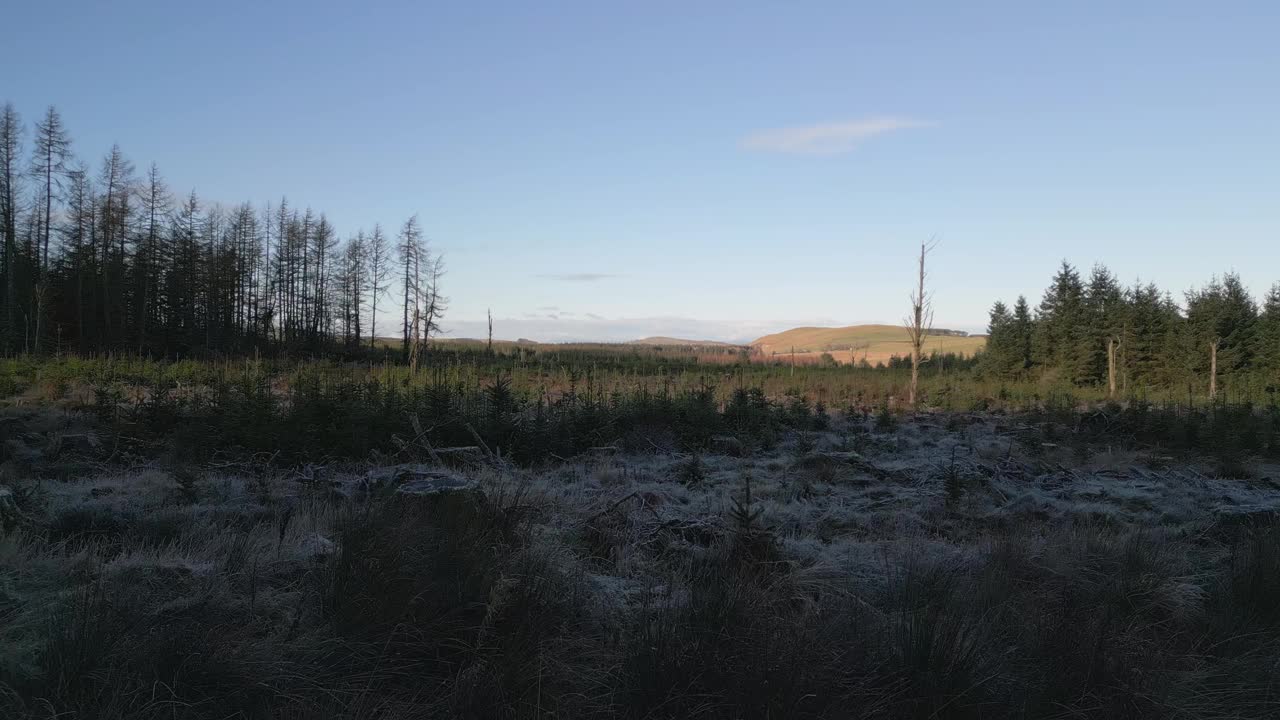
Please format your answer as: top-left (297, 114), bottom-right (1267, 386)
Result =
top-left (0, 105), bottom-right (445, 357)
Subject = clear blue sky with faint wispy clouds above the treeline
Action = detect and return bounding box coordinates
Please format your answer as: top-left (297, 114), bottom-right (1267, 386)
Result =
top-left (0, 1), bottom-right (1280, 340)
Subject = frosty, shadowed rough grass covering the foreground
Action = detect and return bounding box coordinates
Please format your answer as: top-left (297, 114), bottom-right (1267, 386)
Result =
top-left (0, 407), bottom-right (1280, 719)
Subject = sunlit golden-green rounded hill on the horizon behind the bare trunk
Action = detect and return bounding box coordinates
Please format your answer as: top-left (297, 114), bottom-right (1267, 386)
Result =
top-left (751, 325), bottom-right (987, 365)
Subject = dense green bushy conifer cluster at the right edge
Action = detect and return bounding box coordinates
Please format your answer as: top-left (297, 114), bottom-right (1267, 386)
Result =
top-left (980, 261), bottom-right (1280, 397)
